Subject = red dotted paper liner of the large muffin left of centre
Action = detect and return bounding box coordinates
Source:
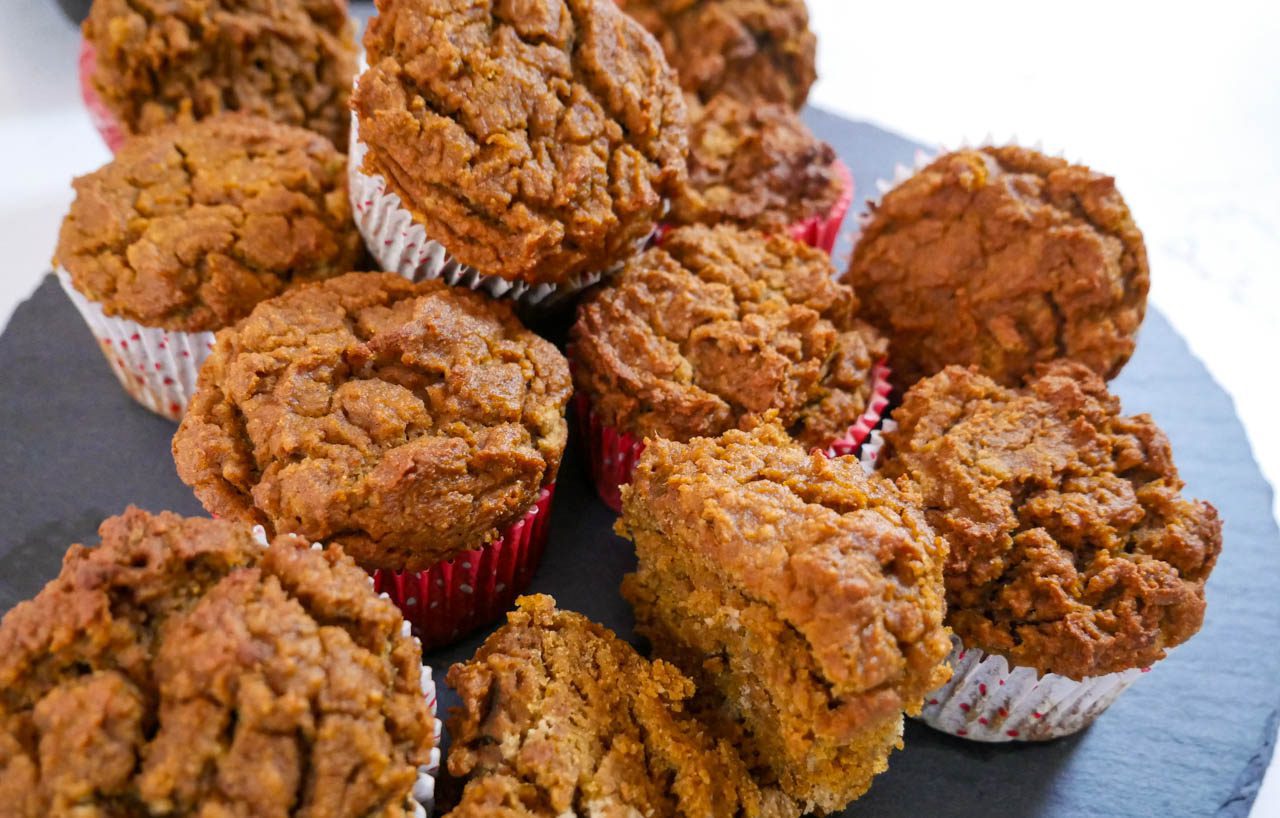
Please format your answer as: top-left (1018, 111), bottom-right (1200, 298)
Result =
top-left (372, 483), bottom-right (556, 650)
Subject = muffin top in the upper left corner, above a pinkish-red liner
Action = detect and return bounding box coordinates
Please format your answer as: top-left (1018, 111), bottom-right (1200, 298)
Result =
top-left (84, 0), bottom-right (356, 148)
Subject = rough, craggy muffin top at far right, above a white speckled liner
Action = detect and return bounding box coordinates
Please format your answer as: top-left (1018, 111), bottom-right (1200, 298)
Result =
top-left (881, 361), bottom-right (1222, 678)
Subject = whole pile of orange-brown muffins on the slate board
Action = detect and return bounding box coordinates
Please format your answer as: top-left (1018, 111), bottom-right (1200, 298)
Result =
top-left (0, 0), bottom-right (1221, 818)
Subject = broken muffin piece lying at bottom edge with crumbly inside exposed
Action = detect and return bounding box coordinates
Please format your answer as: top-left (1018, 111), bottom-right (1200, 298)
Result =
top-left (448, 595), bottom-right (799, 818)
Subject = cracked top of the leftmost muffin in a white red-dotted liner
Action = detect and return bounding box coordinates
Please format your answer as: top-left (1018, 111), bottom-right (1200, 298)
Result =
top-left (55, 114), bottom-right (364, 332)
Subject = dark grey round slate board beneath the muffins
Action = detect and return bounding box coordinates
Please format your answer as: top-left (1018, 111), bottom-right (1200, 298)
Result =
top-left (0, 110), bottom-right (1280, 818)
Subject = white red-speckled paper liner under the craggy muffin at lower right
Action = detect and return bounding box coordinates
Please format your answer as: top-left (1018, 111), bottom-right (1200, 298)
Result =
top-left (920, 636), bottom-right (1151, 741)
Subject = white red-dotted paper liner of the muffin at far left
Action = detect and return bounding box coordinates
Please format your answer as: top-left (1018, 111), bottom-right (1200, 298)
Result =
top-left (58, 269), bottom-right (214, 420)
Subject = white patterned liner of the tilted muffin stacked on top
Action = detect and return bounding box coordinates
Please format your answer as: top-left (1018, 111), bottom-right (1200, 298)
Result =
top-left (347, 115), bottom-right (606, 307)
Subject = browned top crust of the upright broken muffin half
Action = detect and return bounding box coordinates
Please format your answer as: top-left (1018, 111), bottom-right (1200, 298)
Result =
top-left (617, 422), bottom-right (951, 730)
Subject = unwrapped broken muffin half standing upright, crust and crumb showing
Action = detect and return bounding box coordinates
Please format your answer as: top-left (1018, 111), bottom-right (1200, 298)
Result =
top-left (618, 422), bottom-right (951, 812)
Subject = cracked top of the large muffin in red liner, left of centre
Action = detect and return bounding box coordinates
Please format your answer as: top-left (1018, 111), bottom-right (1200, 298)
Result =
top-left (173, 273), bottom-right (571, 571)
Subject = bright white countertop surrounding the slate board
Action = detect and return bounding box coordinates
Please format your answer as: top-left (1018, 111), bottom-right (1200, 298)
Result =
top-left (0, 0), bottom-right (1280, 818)
